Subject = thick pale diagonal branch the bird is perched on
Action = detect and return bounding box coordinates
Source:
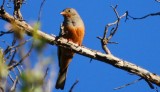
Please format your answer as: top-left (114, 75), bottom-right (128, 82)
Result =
top-left (0, 9), bottom-right (160, 86)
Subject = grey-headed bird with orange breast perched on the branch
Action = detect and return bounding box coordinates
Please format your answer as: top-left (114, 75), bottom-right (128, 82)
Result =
top-left (55, 8), bottom-right (85, 90)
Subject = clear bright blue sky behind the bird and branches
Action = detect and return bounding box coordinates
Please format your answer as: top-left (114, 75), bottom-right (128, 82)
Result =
top-left (0, 0), bottom-right (160, 92)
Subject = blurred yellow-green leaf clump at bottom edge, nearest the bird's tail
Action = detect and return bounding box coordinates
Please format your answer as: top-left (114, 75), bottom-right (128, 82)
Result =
top-left (20, 69), bottom-right (43, 92)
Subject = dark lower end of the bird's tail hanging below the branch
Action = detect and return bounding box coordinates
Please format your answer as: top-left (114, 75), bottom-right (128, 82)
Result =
top-left (56, 68), bottom-right (67, 90)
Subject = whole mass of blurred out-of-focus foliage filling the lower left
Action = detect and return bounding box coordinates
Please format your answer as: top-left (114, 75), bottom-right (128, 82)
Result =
top-left (0, 23), bottom-right (54, 92)
